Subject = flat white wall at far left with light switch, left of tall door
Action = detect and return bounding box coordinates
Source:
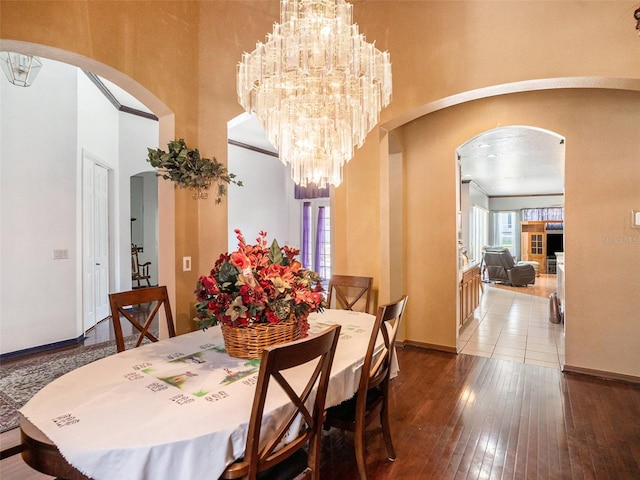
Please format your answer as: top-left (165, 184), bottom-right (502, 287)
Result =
top-left (0, 59), bottom-right (79, 353)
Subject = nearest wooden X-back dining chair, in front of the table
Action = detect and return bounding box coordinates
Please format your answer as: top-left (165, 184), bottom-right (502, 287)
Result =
top-left (221, 325), bottom-right (340, 480)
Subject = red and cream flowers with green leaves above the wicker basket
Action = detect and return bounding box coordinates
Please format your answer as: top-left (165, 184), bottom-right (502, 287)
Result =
top-left (194, 229), bottom-right (326, 337)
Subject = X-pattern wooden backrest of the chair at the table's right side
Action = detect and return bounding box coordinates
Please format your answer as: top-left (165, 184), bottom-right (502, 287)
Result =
top-left (356, 295), bottom-right (408, 394)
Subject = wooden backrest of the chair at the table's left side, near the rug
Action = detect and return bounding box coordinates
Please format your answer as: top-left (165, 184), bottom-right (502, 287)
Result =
top-left (109, 286), bottom-right (176, 352)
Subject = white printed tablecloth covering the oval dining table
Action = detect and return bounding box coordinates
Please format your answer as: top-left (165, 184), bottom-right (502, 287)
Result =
top-left (20, 310), bottom-right (374, 480)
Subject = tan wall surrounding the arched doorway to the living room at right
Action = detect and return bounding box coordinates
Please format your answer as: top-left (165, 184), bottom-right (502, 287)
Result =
top-left (401, 89), bottom-right (640, 376)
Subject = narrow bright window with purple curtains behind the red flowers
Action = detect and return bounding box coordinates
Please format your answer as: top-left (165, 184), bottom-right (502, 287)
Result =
top-left (300, 199), bottom-right (331, 288)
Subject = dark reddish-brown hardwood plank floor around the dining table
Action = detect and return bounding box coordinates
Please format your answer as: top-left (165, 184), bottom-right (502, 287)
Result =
top-left (0, 347), bottom-right (640, 480)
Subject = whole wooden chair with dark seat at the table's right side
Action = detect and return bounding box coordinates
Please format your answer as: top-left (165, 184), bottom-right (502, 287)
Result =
top-left (325, 295), bottom-right (407, 480)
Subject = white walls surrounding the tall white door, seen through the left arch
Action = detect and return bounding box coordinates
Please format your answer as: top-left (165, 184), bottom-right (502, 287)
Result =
top-left (0, 59), bottom-right (158, 354)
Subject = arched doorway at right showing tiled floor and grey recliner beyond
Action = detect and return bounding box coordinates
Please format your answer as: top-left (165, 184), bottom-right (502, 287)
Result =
top-left (456, 125), bottom-right (565, 368)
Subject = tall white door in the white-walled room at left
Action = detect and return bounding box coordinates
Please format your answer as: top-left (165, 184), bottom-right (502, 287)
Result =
top-left (82, 156), bottom-right (109, 332)
